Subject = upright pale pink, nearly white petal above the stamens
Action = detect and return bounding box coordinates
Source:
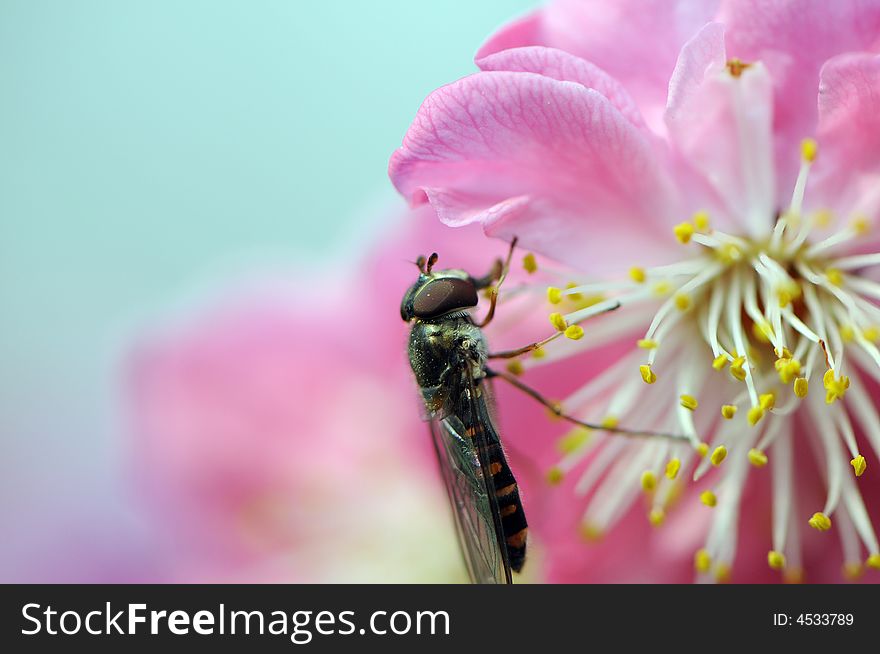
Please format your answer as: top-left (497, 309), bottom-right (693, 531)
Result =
top-left (666, 23), bottom-right (777, 234)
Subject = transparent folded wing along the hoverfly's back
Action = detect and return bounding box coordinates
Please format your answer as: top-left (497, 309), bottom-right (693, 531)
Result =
top-left (431, 413), bottom-right (511, 584)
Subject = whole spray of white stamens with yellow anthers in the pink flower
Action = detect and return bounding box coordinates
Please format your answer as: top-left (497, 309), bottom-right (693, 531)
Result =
top-left (512, 139), bottom-right (880, 578)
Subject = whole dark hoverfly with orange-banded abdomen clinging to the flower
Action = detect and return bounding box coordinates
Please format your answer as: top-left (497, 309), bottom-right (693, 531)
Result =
top-left (400, 238), bottom-right (685, 584)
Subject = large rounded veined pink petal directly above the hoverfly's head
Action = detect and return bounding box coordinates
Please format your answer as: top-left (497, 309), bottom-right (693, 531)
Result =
top-left (389, 72), bottom-right (677, 268)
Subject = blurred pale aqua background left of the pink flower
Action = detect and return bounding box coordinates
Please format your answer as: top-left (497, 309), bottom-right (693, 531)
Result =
top-left (0, 0), bottom-right (534, 580)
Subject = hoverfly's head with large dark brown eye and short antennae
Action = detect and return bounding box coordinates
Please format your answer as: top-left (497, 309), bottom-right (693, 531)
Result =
top-left (400, 252), bottom-right (478, 322)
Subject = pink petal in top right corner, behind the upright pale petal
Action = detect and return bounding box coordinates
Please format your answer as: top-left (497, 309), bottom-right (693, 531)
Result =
top-left (719, 0), bottom-right (880, 194)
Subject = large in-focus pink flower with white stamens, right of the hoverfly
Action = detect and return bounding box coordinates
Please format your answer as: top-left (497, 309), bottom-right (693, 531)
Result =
top-left (390, 0), bottom-right (880, 581)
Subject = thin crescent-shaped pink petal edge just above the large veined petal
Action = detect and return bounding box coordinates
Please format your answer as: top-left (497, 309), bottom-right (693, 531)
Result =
top-left (476, 46), bottom-right (645, 128)
